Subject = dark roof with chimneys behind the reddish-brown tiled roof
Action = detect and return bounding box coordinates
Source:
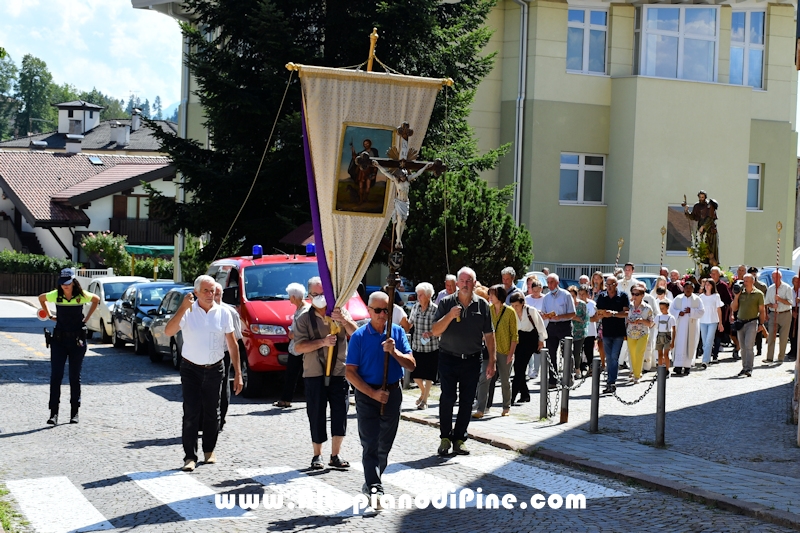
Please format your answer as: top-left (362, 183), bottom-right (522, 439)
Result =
top-left (0, 119), bottom-right (178, 152)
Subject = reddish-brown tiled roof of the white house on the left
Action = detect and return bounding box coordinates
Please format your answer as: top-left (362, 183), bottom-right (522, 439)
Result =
top-left (0, 150), bottom-right (170, 227)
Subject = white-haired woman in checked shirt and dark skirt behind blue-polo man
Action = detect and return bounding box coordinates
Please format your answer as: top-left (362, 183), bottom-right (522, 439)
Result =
top-left (408, 282), bottom-right (439, 409)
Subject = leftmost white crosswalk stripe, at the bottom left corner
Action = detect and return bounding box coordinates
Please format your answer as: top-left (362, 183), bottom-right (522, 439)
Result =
top-left (6, 476), bottom-right (114, 533)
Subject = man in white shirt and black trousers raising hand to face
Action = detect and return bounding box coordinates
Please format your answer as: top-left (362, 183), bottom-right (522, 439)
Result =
top-left (164, 276), bottom-right (243, 472)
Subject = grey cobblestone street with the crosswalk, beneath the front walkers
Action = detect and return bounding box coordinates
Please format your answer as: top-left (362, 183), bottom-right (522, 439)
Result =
top-left (0, 306), bottom-right (789, 532)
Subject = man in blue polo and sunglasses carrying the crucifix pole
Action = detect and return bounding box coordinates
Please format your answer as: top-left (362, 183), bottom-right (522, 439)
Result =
top-left (345, 291), bottom-right (416, 497)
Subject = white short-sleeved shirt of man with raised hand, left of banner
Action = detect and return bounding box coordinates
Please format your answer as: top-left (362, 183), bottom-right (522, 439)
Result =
top-left (181, 301), bottom-right (233, 365)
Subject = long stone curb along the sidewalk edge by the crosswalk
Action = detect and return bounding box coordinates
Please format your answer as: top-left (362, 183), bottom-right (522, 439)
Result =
top-left (400, 413), bottom-right (800, 531)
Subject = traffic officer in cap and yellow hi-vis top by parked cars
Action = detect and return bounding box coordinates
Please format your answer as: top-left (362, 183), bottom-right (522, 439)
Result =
top-left (39, 268), bottom-right (100, 425)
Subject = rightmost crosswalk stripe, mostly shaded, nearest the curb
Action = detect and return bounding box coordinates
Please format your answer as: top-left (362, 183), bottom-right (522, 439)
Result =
top-left (450, 455), bottom-right (629, 499)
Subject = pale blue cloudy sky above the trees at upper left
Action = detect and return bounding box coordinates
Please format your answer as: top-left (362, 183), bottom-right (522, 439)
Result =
top-left (0, 0), bottom-right (181, 110)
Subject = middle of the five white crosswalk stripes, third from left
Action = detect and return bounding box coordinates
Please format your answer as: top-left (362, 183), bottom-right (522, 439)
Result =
top-left (237, 466), bottom-right (353, 516)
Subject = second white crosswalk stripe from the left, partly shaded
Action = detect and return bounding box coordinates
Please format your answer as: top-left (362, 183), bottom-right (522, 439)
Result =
top-left (125, 471), bottom-right (255, 520)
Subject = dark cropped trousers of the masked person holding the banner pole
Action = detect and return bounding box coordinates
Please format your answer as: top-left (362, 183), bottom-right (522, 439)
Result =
top-left (304, 374), bottom-right (350, 444)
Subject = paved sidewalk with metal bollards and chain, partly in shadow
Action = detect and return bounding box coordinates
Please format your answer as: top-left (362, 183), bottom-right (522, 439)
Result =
top-left (403, 350), bottom-right (800, 530)
